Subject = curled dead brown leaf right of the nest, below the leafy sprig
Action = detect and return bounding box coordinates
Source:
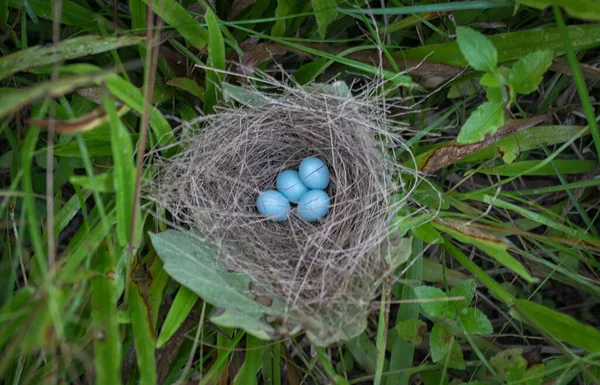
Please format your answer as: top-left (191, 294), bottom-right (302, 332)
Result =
top-left (421, 115), bottom-right (548, 173)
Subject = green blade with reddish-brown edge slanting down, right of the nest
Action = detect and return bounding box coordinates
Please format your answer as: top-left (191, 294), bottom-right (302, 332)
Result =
top-left (434, 223), bottom-right (538, 282)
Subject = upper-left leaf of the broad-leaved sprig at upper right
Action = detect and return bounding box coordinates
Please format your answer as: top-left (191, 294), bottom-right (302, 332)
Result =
top-left (456, 27), bottom-right (498, 73)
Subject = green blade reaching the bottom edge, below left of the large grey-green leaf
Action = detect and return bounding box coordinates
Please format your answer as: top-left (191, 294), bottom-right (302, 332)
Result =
top-left (129, 280), bottom-right (157, 385)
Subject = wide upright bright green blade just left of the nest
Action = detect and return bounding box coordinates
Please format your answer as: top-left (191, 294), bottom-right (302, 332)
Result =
top-left (104, 96), bottom-right (142, 246)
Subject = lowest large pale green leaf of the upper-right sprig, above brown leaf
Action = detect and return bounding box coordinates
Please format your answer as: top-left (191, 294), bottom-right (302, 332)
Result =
top-left (456, 102), bottom-right (504, 144)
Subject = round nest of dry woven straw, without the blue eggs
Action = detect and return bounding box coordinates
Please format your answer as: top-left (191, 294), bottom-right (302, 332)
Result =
top-left (153, 83), bottom-right (422, 340)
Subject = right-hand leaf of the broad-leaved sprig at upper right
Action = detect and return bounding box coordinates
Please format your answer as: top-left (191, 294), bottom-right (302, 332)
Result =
top-left (509, 51), bottom-right (554, 94)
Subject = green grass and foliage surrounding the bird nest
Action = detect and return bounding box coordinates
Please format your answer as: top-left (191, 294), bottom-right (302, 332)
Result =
top-left (0, 0), bottom-right (600, 385)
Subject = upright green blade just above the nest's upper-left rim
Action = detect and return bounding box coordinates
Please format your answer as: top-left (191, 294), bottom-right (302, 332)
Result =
top-left (203, 8), bottom-right (225, 113)
